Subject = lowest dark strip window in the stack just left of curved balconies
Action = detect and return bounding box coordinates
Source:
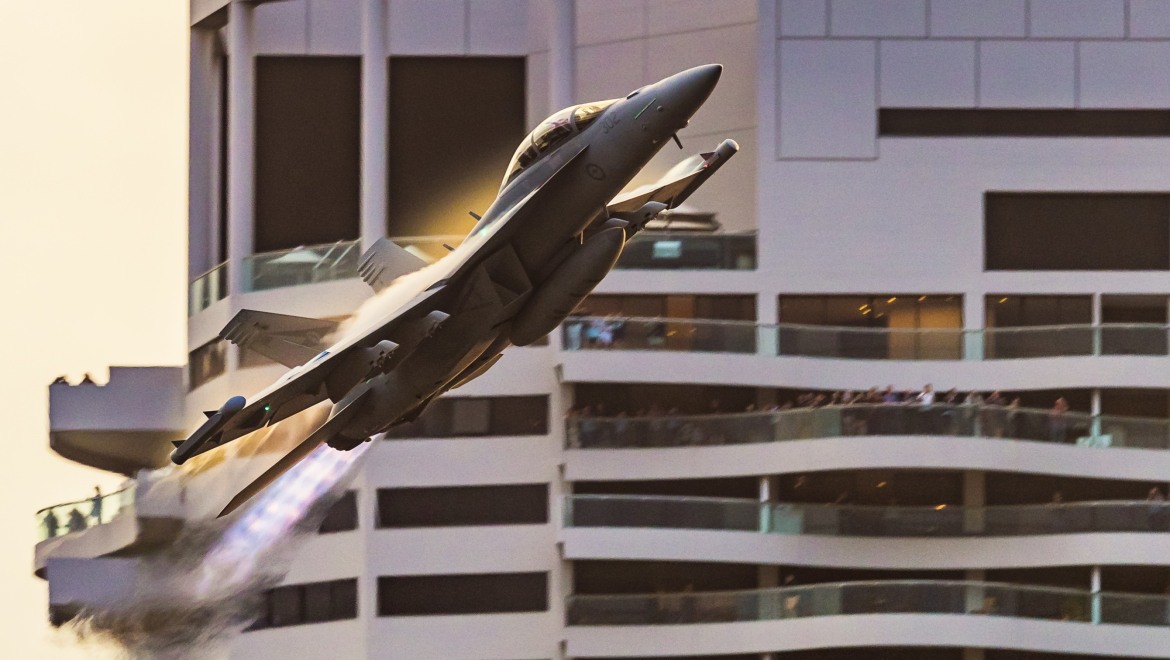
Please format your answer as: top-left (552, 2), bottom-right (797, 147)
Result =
top-left (378, 572), bottom-right (549, 617)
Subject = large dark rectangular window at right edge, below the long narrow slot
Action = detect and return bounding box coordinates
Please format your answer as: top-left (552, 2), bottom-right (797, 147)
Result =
top-left (984, 192), bottom-right (1170, 270)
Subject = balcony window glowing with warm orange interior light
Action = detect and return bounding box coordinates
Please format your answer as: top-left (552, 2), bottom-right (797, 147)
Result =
top-left (779, 294), bottom-right (963, 359)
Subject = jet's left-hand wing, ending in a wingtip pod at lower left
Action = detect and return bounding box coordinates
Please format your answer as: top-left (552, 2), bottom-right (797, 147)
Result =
top-left (171, 286), bottom-right (443, 465)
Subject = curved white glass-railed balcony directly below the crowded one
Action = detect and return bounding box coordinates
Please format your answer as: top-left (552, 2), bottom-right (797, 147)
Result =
top-left (562, 495), bottom-right (1170, 570)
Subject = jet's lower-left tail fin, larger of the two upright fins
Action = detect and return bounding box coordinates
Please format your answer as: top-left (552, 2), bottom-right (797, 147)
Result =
top-left (220, 309), bottom-right (338, 367)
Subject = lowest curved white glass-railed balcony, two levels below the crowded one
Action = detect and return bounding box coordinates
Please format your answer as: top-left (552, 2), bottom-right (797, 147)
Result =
top-left (566, 580), bottom-right (1170, 658)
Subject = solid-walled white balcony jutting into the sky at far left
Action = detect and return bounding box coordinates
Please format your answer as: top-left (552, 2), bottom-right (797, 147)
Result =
top-left (49, 366), bottom-right (184, 475)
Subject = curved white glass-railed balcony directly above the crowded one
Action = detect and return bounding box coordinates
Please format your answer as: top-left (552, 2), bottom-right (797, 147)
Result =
top-left (559, 317), bottom-right (1170, 391)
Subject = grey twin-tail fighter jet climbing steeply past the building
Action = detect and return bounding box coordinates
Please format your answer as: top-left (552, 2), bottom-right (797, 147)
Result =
top-left (171, 64), bottom-right (739, 515)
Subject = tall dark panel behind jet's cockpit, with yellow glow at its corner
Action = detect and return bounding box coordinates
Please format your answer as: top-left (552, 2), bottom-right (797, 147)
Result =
top-left (387, 56), bottom-right (526, 236)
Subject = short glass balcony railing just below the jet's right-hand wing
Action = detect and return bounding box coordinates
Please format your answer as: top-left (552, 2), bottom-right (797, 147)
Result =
top-left (617, 232), bottom-right (756, 270)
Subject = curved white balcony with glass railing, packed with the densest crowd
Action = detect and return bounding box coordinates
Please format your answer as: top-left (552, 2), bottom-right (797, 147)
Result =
top-left (565, 404), bottom-right (1170, 481)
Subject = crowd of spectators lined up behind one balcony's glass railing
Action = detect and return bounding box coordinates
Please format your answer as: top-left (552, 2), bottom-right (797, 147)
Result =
top-left (569, 384), bottom-right (1076, 447)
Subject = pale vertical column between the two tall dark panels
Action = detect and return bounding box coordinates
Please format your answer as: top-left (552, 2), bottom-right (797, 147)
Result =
top-left (362, 0), bottom-right (390, 250)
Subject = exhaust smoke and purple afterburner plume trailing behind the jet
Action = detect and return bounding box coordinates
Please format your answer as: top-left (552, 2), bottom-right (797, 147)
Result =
top-left (62, 408), bottom-right (372, 659)
